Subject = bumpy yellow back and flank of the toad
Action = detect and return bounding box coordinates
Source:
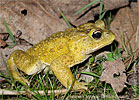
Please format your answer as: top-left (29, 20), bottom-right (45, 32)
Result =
top-left (26, 23), bottom-right (94, 64)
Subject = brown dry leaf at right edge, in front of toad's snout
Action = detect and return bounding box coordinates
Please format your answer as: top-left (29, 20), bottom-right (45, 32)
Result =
top-left (111, 2), bottom-right (139, 51)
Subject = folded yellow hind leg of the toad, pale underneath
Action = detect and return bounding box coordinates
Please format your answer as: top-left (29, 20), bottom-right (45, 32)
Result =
top-left (7, 50), bottom-right (44, 85)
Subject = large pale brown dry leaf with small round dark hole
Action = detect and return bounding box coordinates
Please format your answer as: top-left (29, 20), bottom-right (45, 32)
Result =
top-left (0, 0), bottom-right (67, 44)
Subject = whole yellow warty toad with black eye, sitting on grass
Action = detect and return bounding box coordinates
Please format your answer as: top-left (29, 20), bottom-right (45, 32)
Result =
top-left (7, 20), bottom-right (115, 89)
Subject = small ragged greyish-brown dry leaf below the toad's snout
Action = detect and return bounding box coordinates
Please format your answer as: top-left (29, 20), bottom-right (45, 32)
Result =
top-left (100, 59), bottom-right (126, 92)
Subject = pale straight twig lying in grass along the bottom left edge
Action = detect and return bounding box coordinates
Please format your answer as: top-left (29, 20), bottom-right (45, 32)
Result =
top-left (0, 89), bottom-right (81, 96)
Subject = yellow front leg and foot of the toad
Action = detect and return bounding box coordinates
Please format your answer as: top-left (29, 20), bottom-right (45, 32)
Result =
top-left (50, 54), bottom-right (88, 90)
